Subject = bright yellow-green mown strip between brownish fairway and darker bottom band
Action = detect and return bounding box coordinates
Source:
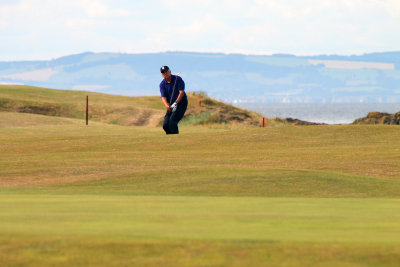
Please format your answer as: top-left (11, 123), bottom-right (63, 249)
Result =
top-left (0, 195), bottom-right (400, 244)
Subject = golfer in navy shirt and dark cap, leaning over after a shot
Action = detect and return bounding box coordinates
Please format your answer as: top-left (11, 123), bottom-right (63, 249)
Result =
top-left (160, 66), bottom-right (188, 134)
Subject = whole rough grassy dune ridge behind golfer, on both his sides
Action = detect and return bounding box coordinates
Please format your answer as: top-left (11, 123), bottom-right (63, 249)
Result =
top-left (0, 85), bottom-right (268, 126)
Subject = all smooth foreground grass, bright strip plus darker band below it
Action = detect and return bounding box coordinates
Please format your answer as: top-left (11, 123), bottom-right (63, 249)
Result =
top-left (0, 195), bottom-right (400, 266)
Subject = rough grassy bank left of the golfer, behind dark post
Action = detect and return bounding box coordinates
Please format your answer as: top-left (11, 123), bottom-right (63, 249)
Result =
top-left (0, 85), bottom-right (163, 126)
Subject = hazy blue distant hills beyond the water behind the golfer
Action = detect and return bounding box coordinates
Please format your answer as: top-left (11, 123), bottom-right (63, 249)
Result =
top-left (0, 52), bottom-right (400, 103)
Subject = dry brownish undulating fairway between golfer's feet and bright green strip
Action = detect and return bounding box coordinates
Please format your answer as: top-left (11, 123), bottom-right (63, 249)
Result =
top-left (0, 124), bottom-right (400, 197)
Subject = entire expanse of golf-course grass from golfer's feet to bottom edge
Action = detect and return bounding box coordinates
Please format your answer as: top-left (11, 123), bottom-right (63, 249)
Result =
top-left (0, 110), bottom-right (400, 266)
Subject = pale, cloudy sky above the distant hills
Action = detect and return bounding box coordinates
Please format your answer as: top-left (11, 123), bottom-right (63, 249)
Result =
top-left (0, 0), bottom-right (400, 61)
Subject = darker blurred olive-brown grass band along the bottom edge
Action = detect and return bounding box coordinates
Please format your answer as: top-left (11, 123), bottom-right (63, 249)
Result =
top-left (4, 236), bottom-right (400, 266)
